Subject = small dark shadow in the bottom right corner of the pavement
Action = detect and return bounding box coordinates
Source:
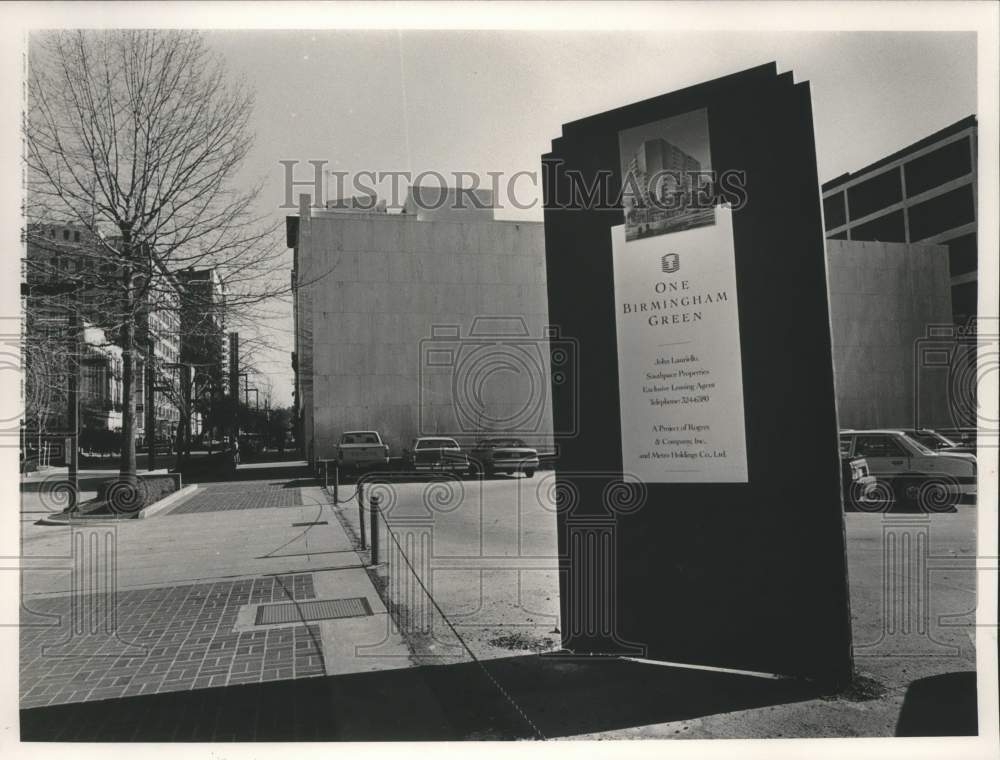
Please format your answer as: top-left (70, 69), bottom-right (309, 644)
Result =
top-left (896, 671), bottom-right (979, 736)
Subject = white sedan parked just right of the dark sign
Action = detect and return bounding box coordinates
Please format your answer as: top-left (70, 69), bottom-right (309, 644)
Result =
top-left (840, 429), bottom-right (976, 511)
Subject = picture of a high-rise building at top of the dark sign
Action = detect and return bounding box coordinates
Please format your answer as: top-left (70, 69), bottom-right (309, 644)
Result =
top-left (618, 109), bottom-right (715, 240)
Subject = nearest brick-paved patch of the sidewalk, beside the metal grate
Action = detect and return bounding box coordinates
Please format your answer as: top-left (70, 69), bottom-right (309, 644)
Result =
top-left (20, 572), bottom-right (325, 708)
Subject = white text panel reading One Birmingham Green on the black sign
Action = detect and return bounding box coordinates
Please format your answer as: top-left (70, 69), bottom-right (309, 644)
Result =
top-left (611, 207), bottom-right (748, 483)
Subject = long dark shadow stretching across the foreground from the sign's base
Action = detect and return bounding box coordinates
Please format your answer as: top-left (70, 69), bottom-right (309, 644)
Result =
top-left (21, 655), bottom-right (820, 741)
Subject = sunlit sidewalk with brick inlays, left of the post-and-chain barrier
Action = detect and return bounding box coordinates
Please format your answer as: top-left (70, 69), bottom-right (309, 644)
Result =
top-left (20, 470), bottom-right (410, 708)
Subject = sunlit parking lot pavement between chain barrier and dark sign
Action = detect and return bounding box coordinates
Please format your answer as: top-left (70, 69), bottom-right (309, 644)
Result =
top-left (328, 472), bottom-right (560, 665)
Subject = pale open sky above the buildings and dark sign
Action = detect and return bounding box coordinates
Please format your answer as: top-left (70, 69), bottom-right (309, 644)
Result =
top-left (207, 30), bottom-right (976, 404)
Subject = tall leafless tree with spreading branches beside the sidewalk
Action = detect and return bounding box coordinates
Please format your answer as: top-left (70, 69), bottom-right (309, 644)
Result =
top-left (24, 30), bottom-right (288, 482)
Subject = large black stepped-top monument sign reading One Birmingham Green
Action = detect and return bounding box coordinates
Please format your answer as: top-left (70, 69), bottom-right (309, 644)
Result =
top-left (543, 64), bottom-right (852, 683)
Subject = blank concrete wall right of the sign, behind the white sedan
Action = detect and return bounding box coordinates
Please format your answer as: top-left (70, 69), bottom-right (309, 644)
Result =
top-left (826, 240), bottom-right (954, 428)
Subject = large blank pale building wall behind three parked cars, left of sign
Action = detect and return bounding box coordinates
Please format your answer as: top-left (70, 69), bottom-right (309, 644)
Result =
top-left (288, 193), bottom-right (552, 459)
